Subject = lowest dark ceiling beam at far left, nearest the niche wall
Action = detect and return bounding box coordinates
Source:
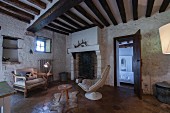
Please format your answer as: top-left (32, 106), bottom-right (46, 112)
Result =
top-left (0, 7), bottom-right (30, 23)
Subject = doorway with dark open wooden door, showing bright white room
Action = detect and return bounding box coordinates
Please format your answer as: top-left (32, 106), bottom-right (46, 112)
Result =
top-left (113, 30), bottom-right (142, 98)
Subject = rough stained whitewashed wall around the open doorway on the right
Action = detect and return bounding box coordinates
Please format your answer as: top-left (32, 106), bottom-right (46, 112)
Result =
top-left (103, 10), bottom-right (170, 94)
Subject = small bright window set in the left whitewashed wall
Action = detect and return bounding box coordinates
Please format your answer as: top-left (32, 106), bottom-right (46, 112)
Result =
top-left (35, 37), bottom-right (51, 53)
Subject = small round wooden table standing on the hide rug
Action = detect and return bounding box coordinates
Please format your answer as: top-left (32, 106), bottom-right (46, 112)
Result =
top-left (58, 84), bottom-right (72, 102)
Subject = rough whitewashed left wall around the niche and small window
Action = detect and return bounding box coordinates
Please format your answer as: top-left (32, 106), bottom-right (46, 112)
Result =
top-left (0, 14), bottom-right (65, 84)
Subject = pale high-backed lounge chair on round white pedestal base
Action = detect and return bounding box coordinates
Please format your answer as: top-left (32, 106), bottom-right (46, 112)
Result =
top-left (78, 65), bottom-right (110, 100)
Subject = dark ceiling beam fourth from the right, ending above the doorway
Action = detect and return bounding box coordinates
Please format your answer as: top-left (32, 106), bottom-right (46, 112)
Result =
top-left (116, 0), bottom-right (127, 23)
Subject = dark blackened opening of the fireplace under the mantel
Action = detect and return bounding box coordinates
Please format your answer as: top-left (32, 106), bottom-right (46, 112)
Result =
top-left (75, 51), bottom-right (97, 79)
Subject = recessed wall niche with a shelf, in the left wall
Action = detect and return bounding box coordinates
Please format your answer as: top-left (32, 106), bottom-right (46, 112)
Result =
top-left (2, 35), bottom-right (22, 64)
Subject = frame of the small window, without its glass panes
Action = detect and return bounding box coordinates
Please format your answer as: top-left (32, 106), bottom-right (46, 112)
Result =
top-left (35, 36), bottom-right (52, 53)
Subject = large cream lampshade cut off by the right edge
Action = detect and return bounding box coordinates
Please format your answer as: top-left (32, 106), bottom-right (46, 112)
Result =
top-left (159, 23), bottom-right (170, 54)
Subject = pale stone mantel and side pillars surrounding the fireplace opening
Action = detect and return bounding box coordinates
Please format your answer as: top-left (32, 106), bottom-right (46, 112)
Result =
top-left (68, 45), bottom-right (101, 80)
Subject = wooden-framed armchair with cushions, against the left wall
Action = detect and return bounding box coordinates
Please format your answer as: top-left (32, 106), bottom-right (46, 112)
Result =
top-left (13, 68), bottom-right (47, 97)
